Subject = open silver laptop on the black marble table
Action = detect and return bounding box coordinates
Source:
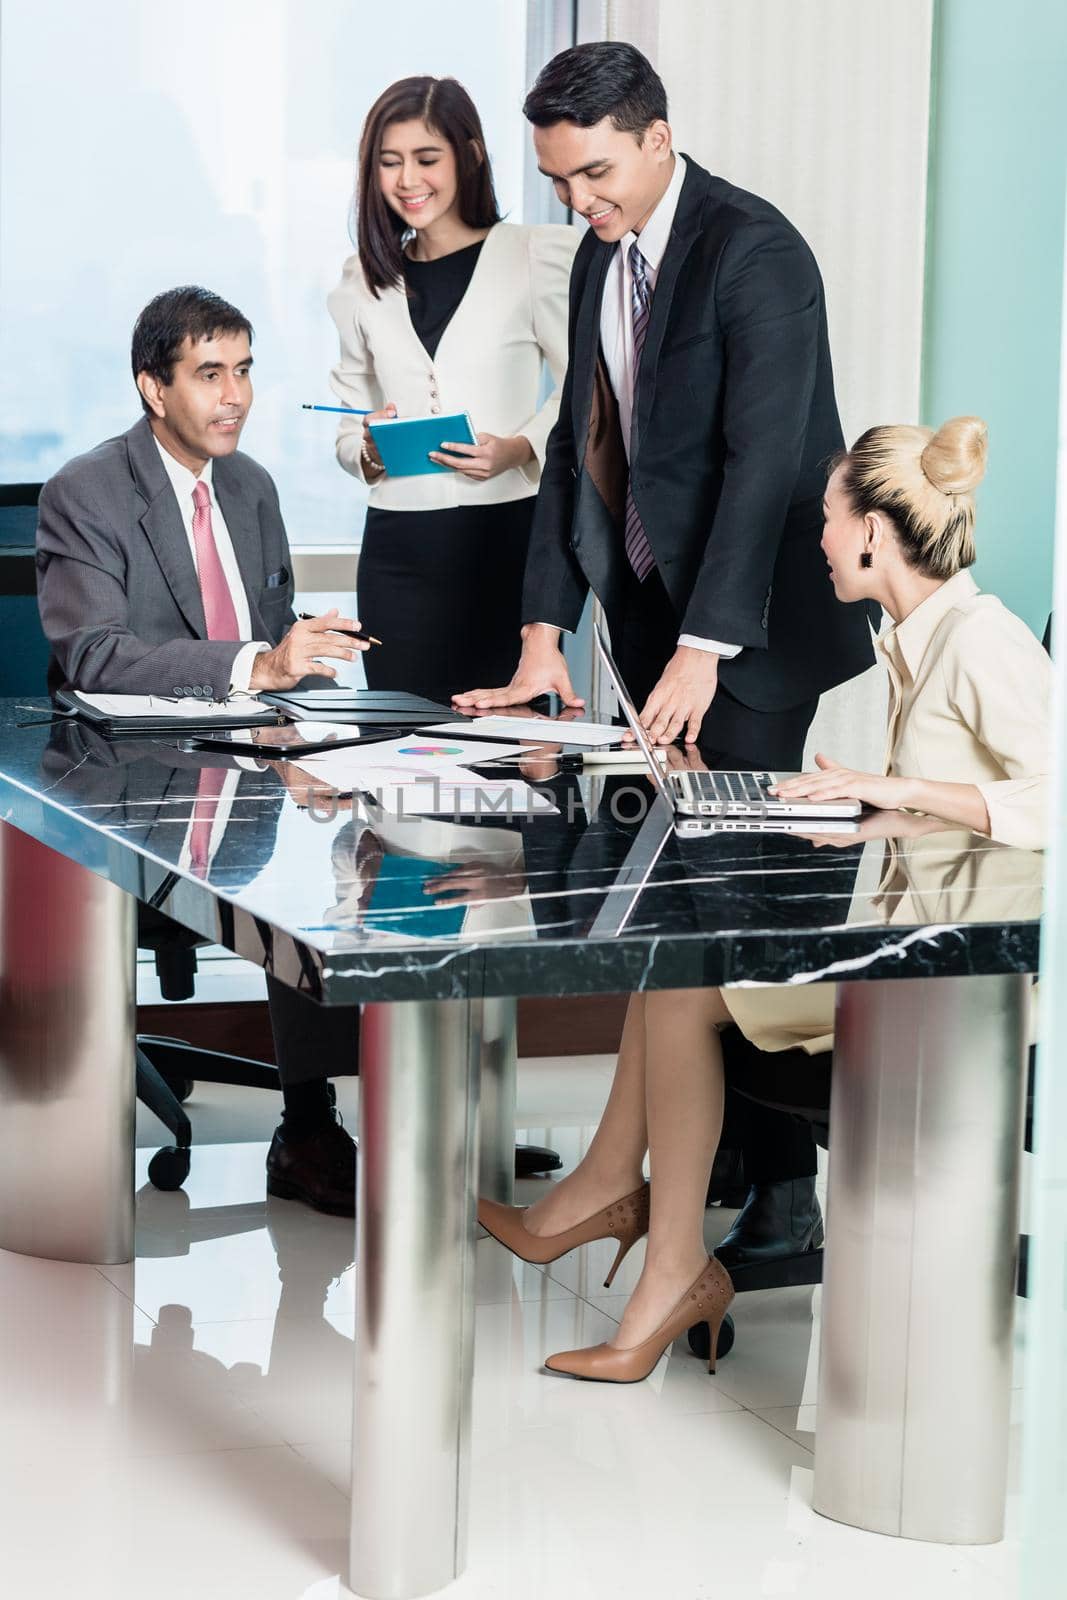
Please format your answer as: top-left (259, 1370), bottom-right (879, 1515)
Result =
top-left (593, 626), bottom-right (862, 834)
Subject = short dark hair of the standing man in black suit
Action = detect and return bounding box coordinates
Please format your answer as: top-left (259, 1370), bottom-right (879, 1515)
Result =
top-left (523, 40), bottom-right (667, 134)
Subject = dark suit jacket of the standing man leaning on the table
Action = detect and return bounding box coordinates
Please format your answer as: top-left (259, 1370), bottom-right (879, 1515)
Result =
top-left (523, 157), bottom-right (873, 710)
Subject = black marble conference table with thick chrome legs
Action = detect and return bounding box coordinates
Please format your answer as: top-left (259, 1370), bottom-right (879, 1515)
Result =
top-left (0, 701), bottom-right (1041, 1595)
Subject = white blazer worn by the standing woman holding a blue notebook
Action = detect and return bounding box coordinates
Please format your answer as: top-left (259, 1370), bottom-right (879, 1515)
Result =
top-left (326, 222), bottom-right (581, 510)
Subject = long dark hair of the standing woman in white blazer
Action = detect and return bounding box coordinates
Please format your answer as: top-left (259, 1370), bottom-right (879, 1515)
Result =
top-left (352, 77), bottom-right (501, 298)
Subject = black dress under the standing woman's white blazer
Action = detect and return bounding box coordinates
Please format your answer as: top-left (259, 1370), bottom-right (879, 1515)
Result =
top-left (357, 243), bottom-right (536, 702)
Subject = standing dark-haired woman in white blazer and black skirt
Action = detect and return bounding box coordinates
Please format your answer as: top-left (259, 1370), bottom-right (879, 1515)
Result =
top-left (330, 77), bottom-right (577, 701)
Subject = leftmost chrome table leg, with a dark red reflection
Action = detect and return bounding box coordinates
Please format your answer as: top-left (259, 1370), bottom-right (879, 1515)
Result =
top-left (0, 822), bottom-right (136, 1262)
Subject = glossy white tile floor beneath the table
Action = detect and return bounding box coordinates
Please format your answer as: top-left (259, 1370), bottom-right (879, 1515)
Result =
top-left (0, 1058), bottom-right (1021, 1600)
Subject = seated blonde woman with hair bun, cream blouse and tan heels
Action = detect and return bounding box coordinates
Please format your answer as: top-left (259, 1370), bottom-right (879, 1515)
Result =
top-left (478, 418), bottom-right (1051, 1382)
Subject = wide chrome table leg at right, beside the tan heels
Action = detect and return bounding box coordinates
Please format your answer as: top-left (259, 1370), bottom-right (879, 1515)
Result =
top-left (814, 976), bottom-right (1030, 1544)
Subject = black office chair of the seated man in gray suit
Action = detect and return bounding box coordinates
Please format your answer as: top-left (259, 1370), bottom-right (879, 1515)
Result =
top-left (0, 483), bottom-right (280, 1189)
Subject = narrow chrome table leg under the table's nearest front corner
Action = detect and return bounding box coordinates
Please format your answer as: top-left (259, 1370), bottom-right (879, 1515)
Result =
top-left (349, 1000), bottom-right (482, 1600)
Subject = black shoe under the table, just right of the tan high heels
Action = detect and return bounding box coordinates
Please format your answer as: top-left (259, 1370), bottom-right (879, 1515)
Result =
top-left (715, 1178), bottom-right (824, 1291)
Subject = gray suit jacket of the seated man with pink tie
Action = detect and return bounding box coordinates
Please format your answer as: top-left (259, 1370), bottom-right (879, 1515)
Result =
top-left (37, 418), bottom-right (293, 699)
